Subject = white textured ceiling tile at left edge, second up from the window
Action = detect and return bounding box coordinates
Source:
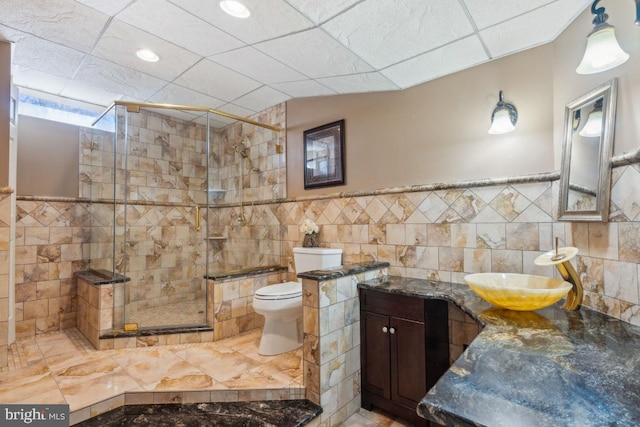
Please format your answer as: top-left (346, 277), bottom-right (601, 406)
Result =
top-left (0, 25), bottom-right (85, 77)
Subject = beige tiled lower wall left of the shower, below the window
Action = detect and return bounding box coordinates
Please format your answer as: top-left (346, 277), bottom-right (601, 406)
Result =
top-left (15, 198), bottom-right (90, 338)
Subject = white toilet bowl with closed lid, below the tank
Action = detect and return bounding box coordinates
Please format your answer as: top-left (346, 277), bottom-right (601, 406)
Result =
top-left (253, 282), bottom-right (302, 356)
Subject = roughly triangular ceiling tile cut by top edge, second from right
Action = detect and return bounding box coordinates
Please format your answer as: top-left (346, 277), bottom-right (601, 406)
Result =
top-left (464, 0), bottom-right (555, 30)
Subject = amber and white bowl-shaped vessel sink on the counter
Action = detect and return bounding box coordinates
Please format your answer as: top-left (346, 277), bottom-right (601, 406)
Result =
top-left (464, 273), bottom-right (572, 311)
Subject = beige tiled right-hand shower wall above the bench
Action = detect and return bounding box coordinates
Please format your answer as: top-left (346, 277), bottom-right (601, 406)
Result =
top-left (208, 103), bottom-right (286, 271)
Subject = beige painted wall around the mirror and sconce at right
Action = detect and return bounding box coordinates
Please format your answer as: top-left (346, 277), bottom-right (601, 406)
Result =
top-left (553, 0), bottom-right (640, 169)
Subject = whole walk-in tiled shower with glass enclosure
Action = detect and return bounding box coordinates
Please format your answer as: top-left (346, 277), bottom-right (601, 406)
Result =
top-left (88, 102), bottom-right (286, 329)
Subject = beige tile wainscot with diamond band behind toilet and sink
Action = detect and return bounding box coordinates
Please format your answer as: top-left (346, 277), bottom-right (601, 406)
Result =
top-left (280, 164), bottom-right (640, 324)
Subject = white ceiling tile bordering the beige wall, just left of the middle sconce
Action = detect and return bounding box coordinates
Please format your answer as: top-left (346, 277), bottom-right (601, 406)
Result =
top-left (381, 35), bottom-right (489, 89)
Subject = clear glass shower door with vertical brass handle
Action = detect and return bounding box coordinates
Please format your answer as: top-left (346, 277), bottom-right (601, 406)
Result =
top-left (114, 106), bottom-right (208, 329)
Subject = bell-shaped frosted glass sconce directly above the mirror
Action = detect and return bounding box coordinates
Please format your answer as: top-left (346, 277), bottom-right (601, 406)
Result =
top-left (576, 0), bottom-right (628, 74)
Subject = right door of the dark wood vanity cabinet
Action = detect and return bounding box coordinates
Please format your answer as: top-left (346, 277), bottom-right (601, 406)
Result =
top-left (389, 317), bottom-right (427, 407)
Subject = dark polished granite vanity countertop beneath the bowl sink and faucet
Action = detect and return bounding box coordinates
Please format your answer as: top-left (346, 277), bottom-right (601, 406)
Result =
top-left (359, 276), bottom-right (640, 427)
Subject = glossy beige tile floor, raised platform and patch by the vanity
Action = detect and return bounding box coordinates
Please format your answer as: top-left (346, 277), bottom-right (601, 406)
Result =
top-left (0, 328), bottom-right (410, 427)
